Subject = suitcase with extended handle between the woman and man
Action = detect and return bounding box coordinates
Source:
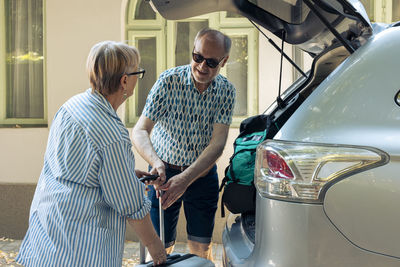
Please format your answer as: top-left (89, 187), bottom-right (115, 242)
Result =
top-left (136, 192), bottom-right (215, 267)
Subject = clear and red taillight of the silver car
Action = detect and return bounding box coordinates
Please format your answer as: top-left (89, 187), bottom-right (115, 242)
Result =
top-left (254, 140), bottom-right (390, 203)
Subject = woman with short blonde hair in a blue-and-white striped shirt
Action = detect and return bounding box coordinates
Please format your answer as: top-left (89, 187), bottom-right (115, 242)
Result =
top-left (17, 41), bottom-right (166, 267)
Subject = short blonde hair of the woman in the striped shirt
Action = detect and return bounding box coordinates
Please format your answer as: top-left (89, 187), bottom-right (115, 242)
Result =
top-left (86, 41), bottom-right (140, 96)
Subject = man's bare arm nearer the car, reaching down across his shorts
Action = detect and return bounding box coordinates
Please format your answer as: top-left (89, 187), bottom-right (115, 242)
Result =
top-left (160, 123), bottom-right (229, 209)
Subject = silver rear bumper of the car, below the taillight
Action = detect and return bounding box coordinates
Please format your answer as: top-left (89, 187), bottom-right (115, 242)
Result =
top-left (223, 195), bottom-right (399, 267)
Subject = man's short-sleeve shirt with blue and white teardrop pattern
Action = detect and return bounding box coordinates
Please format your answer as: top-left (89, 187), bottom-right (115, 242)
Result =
top-left (143, 65), bottom-right (236, 166)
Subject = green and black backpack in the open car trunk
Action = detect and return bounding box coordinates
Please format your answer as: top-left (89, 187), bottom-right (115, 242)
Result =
top-left (220, 115), bottom-right (276, 217)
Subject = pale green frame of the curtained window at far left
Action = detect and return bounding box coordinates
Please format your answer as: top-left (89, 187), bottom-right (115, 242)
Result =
top-left (0, 0), bottom-right (48, 128)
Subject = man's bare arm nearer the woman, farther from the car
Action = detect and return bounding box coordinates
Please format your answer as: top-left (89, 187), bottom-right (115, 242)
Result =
top-left (132, 114), bottom-right (166, 184)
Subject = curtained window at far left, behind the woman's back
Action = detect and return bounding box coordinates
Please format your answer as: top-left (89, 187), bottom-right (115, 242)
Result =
top-left (0, 0), bottom-right (46, 127)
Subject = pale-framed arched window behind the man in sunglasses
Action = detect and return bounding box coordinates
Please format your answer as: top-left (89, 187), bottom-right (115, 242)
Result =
top-left (125, 0), bottom-right (258, 127)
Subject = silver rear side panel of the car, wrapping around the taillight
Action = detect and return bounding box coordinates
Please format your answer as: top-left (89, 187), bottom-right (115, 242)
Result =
top-left (275, 28), bottom-right (400, 260)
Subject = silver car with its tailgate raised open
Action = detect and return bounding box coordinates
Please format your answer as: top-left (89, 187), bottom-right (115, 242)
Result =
top-left (151, 0), bottom-right (400, 267)
